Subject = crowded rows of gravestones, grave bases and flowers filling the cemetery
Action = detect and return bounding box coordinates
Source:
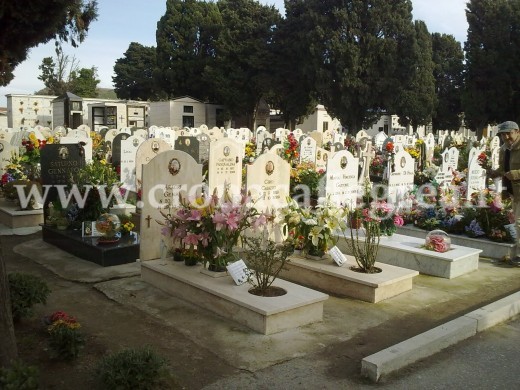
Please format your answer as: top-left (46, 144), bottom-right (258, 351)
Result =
top-left (0, 125), bottom-right (515, 334)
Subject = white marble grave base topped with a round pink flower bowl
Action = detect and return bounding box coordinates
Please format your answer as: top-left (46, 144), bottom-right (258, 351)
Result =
top-left (338, 233), bottom-right (482, 279)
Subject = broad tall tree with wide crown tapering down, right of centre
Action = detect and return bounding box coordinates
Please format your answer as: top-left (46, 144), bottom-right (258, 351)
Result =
top-left (298, 0), bottom-right (414, 132)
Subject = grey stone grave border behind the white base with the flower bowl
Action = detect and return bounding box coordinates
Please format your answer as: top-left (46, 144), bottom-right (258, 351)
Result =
top-left (397, 225), bottom-right (515, 260)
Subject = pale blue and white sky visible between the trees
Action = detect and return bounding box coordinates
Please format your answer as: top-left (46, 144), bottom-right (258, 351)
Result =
top-left (0, 0), bottom-right (468, 107)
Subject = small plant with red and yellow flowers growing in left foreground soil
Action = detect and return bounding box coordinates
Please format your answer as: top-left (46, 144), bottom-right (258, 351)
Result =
top-left (44, 311), bottom-right (85, 360)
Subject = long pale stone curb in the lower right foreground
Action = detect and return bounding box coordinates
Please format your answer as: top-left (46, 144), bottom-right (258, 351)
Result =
top-left (361, 292), bottom-right (520, 382)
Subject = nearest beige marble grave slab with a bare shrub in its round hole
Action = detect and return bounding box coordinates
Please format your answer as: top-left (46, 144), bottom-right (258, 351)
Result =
top-left (141, 259), bottom-right (328, 334)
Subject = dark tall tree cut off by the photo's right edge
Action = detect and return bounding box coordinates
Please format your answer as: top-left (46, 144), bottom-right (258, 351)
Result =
top-left (463, 0), bottom-right (520, 135)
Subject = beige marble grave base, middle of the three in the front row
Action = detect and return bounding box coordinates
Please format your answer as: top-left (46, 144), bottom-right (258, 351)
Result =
top-left (280, 255), bottom-right (419, 303)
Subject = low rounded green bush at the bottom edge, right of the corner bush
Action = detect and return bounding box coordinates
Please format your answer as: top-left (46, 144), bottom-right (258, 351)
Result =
top-left (96, 347), bottom-right (177, 390)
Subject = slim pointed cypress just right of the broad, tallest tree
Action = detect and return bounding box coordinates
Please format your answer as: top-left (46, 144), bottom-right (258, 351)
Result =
top-left (392, 20), bottom-right (435, 132)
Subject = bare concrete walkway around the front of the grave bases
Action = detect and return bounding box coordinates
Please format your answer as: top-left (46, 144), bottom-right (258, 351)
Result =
top-left (4, 224), bottom-right (520, 389)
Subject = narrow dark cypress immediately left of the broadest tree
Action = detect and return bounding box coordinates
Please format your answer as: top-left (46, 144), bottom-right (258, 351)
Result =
top-left (267, 2), bottom-right (318, 129)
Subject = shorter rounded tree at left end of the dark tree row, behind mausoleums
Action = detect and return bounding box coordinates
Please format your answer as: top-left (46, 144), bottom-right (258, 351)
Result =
top-left (112, 42), bottom-right (158, 100)
